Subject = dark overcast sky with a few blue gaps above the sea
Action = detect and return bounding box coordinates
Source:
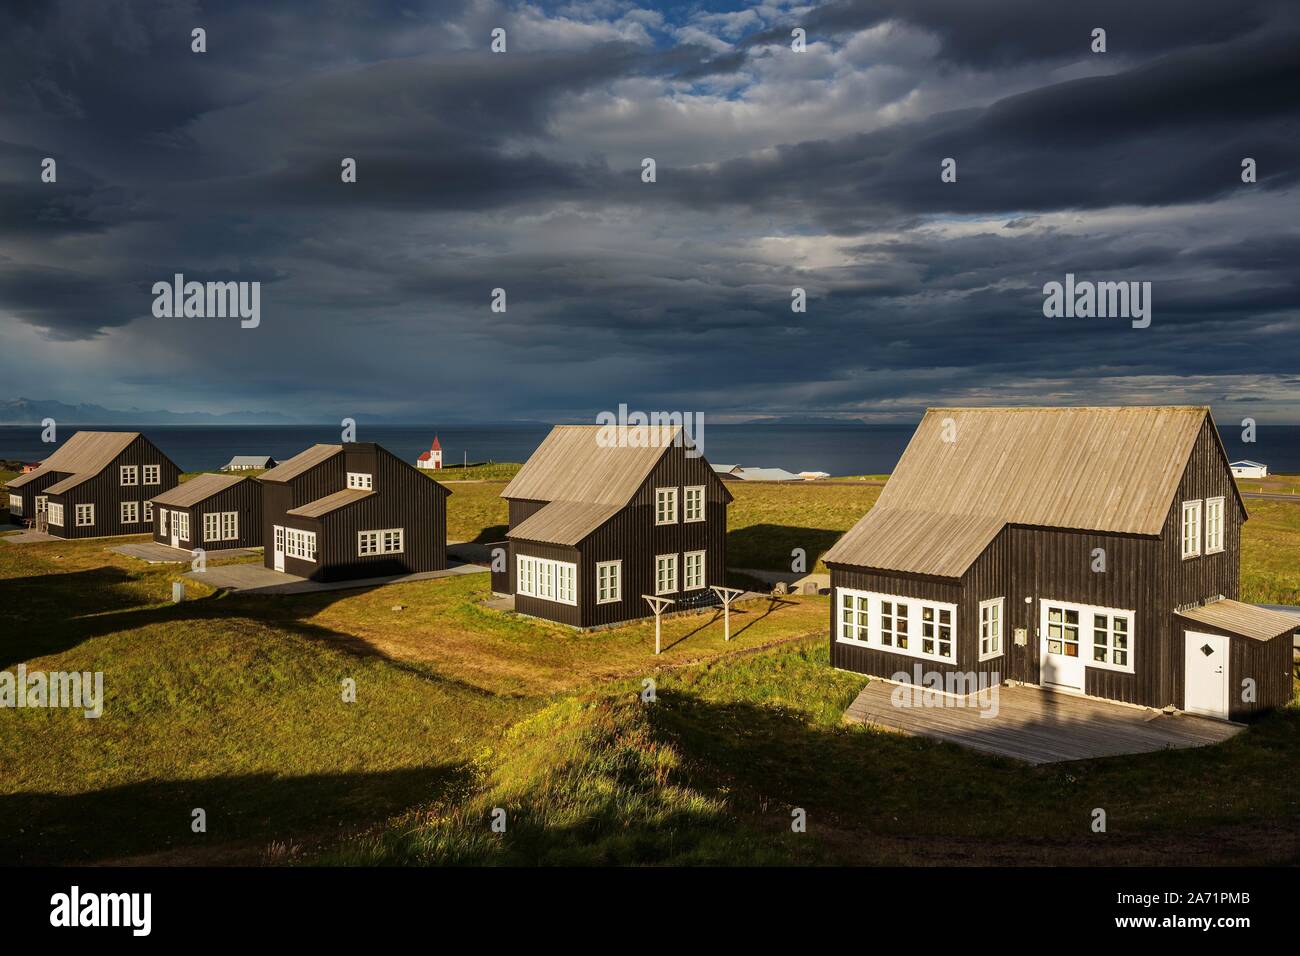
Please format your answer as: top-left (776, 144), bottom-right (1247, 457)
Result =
top-left (0, 0), bottom-right (1300, 421)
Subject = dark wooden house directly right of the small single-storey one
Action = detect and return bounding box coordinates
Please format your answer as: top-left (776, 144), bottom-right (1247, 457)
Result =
top-left (257, 442), bottom-right (451, 581)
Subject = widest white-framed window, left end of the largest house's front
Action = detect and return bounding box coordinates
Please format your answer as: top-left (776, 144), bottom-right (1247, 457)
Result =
top-left (836, 588), bottom-right (957, 663)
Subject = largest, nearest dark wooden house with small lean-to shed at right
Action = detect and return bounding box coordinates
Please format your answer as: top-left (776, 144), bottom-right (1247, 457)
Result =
top-left (823, 407), bottom-right (1297, 718)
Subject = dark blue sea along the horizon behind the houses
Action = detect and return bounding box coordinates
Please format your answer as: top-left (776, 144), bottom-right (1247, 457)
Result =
top-left (0, 423), bottom-right (1300, 475)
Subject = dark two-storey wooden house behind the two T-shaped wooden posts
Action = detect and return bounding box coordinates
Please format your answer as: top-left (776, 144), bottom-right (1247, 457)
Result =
top-left (493, 425), bottom-right (732, 627)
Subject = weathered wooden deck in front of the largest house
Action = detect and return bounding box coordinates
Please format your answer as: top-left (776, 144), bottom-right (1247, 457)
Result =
top-left (844, 680), bottom-right (1244, 763)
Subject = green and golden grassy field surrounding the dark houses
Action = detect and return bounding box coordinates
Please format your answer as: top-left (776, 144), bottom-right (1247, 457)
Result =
top-left (0, 480), bottom-right (1300, 864)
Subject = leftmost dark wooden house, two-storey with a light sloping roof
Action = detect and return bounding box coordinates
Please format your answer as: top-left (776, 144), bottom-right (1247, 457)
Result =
top-left (5, 432), bottom-right (181, 538)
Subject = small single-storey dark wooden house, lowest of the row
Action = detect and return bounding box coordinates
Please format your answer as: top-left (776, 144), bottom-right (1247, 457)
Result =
top-left (153, 475), bottom-right (261, 551)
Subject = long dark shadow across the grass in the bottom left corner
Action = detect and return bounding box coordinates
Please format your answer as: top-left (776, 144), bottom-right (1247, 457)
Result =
top-left (0, 763), bottom-right (472, 865)
